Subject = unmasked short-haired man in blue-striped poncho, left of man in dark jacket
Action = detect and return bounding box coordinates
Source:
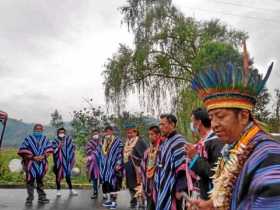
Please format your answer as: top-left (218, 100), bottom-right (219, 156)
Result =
top-left (154, 114), bottom-right (188, 210)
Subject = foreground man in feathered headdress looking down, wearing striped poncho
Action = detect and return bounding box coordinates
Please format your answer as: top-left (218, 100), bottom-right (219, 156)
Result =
top-left (191, 41), bottom-right (280, 210)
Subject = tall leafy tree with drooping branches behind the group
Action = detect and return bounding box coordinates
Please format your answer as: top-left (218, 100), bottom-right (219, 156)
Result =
top-left (103, 0), bottom-right (247, 128)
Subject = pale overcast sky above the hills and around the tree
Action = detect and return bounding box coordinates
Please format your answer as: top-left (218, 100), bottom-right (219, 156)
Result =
top-left (0, 0), bottom-right (280, 123)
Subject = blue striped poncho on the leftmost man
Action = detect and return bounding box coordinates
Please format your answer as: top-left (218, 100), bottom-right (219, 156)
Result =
top-left (18, 135), bottom-right (53, 181)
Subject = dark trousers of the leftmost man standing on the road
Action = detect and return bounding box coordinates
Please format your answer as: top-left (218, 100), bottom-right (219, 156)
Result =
top-left (26, 177), bottom-right (46, 201)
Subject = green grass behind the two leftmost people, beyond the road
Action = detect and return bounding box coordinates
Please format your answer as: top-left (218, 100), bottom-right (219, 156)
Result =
top-left (0, 148), bottom-right (89, 188)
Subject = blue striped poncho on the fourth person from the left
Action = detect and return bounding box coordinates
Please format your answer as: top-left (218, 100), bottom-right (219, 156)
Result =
top-left (101, 137), bottom-right (123, 188)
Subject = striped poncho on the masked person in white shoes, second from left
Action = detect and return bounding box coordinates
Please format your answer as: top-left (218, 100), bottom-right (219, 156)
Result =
top-left (52, 136), bottom-right (75, 181)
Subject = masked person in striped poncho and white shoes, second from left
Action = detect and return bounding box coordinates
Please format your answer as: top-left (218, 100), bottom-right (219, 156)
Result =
top-left (52, 128), bottom-right (78, 197)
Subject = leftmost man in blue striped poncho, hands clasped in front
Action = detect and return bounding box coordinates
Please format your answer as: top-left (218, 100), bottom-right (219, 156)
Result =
top-left (18, 124), bottom-right (53, 206)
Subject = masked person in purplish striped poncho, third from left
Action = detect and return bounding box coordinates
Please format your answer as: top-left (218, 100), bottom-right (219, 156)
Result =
top-left (86, 130), bottom-right (102, 199)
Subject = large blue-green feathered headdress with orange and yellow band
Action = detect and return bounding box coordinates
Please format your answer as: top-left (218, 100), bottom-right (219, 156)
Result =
top-left (192, 42), bottom-right (273, 111)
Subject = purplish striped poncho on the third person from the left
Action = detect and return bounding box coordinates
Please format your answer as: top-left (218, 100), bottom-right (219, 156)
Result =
top-left (86, 139), bottom-right (102, 180)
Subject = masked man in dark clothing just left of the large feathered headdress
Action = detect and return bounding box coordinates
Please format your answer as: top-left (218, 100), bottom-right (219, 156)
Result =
top-left (185, 108), bottom-right (224, 199)
